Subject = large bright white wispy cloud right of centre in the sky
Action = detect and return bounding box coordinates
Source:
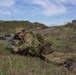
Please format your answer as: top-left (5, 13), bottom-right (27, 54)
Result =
top-left (24, 0), bottom-right (66, 16)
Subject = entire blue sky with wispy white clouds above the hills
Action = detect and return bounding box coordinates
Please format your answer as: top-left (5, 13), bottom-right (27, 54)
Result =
top-left (0, 0), bottom-right (76, 26)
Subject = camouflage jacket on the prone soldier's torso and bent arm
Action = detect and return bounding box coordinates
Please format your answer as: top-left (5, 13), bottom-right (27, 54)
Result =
top-left (14, 32), bottom-right (41, 55)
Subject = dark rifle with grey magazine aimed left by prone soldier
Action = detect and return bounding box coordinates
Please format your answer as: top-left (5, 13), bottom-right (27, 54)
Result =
top-left (0, 34), bottom-right (19, 47)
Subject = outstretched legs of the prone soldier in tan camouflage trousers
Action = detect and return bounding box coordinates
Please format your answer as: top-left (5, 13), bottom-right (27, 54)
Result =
top-left (43, 52), bottom-right (76, 65)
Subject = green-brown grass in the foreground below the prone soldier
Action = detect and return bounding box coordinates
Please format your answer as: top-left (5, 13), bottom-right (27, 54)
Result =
top-left (0, 39), bottom-right (75, 75)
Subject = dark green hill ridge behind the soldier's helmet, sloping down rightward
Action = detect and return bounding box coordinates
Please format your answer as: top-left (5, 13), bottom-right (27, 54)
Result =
top-left (0, 20), bottom-right (47, 33)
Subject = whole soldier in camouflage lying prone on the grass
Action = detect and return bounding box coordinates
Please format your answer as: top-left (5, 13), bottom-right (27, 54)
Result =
top-left (12, 27), bottom-right (76, 65)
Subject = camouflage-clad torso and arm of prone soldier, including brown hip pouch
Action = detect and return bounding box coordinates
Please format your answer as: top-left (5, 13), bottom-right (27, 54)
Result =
top-left (14, 32), bottom-right (53, 55)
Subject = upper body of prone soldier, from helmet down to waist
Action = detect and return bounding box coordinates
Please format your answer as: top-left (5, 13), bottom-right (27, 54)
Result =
top-left (12, 27), bottom-right (53, 56)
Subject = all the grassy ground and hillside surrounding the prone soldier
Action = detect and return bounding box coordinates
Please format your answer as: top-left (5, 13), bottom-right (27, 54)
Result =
top-left (0, 21), bottom-right (76, 75)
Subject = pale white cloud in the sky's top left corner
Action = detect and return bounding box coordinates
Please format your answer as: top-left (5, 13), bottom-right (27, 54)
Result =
top-left (0, 0), bottom-right (15, 15)
